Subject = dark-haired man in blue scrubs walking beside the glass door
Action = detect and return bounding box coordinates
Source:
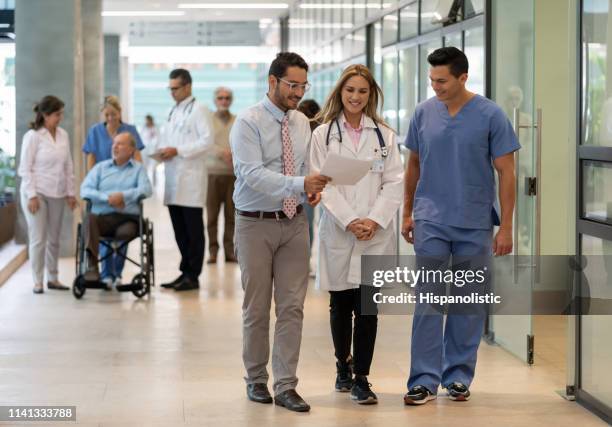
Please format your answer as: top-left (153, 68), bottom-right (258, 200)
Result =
top-left (402, 47), bottom-right (520, 405)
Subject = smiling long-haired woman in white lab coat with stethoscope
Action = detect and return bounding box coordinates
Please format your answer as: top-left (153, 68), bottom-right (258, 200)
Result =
top-left (310, 65), bottom-right (403, 404)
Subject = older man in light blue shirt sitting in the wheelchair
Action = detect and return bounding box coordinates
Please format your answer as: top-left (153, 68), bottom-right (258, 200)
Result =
top-left (81, 132), bottom-right (152, 285)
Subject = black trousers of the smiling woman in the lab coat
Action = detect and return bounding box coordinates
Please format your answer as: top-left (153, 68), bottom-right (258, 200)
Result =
top-left (329, 286), bottom-right (378, 375)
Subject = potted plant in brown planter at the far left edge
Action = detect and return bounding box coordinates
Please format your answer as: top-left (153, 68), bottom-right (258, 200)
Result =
top-left (0, 149), bottom-right (17, 245)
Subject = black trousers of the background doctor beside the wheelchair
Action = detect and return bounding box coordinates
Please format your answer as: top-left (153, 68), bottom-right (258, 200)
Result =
top-left (168, 205), bottom-right (205, 280)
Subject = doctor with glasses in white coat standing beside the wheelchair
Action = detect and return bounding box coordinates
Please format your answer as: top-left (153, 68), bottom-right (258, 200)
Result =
top-left (157, 68), bottom-right (213, 291)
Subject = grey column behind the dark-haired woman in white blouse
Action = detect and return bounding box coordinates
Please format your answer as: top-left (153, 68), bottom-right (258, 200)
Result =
top-left (15, 0), bottom-right (102, 256)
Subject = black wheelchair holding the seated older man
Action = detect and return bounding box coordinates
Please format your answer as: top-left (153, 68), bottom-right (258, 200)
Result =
top-left (72, 198), bottom-right (155, 299)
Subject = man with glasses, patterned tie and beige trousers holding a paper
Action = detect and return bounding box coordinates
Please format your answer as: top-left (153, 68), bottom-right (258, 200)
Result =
top-left (230, 52), bottom-right (328, 412)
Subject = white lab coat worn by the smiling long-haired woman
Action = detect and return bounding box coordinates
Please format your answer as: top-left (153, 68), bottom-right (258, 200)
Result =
top-left (310, 114), bottom-right (404, 291)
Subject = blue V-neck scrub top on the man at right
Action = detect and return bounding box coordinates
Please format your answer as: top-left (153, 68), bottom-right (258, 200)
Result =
top-left (406, 95), bottom-right (521, 230)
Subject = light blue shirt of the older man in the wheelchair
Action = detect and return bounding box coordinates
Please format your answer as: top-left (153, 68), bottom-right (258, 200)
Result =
top-left (81, 159), bottom-right (153, 215)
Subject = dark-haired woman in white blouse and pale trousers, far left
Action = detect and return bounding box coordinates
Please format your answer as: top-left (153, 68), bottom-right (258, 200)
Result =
top-left (19, 95), bottom-right (77, 294)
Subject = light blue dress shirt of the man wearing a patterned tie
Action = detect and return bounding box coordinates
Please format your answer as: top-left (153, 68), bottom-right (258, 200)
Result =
top-left (230, 95), bottom-right (310, 212)
